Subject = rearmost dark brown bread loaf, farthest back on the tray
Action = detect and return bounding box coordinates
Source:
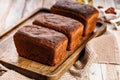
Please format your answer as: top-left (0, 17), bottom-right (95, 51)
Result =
top-left (51, 0), bottom-right (99, 36)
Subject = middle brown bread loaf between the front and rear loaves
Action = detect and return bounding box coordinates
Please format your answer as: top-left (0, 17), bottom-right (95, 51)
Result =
top-left (33, 13), bottom-right (83, 50)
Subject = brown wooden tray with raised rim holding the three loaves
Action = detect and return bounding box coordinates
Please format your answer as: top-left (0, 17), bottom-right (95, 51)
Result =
top-left (0, 9), bottom-right (106, 80)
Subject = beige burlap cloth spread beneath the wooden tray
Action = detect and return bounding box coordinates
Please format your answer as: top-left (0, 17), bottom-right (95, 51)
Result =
top-left (0, 28), bottom-right (120, 80)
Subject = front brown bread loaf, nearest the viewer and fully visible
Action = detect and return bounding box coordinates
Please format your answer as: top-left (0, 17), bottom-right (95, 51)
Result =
top-left (14, 25), bottom-right (68, 65)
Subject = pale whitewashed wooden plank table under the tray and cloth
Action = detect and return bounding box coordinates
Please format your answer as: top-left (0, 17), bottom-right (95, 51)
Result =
top-left (0, 0), bottom-right (120, 80)
